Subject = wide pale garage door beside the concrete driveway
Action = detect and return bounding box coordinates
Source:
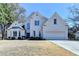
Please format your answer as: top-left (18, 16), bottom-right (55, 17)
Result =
top-left (44, 31), bottom-right (65, 39)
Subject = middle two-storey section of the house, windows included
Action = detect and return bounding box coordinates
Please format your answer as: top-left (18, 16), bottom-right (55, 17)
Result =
top-left (25, 12), bottom-right (47, 37)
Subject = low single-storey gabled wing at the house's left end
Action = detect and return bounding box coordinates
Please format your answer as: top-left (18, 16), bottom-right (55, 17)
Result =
top-left (7, 21), bottom-right (25, 39)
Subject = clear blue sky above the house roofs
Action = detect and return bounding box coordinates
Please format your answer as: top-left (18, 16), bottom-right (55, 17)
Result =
top-left (20, 3), bottom-right (79, 25)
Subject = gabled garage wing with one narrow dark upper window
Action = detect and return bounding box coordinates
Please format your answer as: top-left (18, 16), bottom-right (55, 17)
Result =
top-left (43, 13), bottom-right (68, 39)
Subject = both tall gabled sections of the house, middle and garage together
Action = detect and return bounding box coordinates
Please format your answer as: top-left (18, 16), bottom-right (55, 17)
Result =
top-left (25, 12), bottom-right (68, 39)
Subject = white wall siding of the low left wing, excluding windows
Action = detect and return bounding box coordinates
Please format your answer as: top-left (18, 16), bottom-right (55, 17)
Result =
top-left (7, 22), bottom-right (25, 38)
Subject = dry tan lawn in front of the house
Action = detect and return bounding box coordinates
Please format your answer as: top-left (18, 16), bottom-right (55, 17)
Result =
top-left (0, 40), bottom-right (75, 56)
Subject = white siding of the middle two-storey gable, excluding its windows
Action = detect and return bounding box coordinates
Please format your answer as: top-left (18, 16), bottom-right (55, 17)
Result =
top-left (29, 12), bottom-right (47, 37)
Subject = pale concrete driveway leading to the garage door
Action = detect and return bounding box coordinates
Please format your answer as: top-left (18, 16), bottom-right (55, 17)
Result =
top-left (51, 40), bottom-right (79, 55)
